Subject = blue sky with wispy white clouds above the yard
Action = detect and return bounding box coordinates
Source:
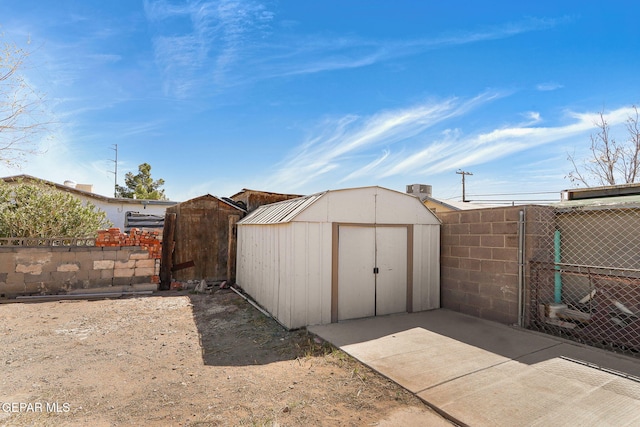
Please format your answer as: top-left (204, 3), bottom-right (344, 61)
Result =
top-left (0, 0), bottom-right (640, 201)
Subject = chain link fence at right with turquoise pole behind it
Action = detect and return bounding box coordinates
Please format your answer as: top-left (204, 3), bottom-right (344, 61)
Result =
top-left (527, 205), bottom-right (640, 357)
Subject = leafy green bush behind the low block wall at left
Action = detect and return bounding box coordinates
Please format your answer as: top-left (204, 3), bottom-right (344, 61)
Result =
top-left (0, 180), bottom-right (111, 238)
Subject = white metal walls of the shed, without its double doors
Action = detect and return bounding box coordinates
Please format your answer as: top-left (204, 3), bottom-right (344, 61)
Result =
top-left (237, 187), bottom-right (440, 329)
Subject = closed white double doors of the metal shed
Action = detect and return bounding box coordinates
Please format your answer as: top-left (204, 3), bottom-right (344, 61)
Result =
top-left (338, 226), bottom-right (408, 320)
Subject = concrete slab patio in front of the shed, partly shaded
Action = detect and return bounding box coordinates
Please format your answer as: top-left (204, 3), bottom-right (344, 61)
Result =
top-left (308, 309), bottom-right (640, 426)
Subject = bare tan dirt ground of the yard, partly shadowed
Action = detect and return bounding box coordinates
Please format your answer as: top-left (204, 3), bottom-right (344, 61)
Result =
top-left (0, 290), bottom-right (448, 426)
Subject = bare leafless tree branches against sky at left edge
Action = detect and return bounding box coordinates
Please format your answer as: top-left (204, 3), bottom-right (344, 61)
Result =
top-left (0, 33), bottom-right (51, 166)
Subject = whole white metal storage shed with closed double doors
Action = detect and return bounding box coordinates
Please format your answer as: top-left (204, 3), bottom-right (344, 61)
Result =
top-left (237, 187), bottom-right (440, 329)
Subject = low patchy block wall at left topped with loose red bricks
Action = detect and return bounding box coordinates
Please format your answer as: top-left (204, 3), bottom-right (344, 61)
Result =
top-left (0, 229), bottom-right (161, 298)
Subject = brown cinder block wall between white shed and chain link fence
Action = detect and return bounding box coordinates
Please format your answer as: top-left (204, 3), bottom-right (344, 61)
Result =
top-left (438, 207), bottom-right (523, 324)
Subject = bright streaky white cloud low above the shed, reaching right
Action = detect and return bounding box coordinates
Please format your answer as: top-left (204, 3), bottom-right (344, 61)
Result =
top-left (266, 101), bottom-right (632, 191)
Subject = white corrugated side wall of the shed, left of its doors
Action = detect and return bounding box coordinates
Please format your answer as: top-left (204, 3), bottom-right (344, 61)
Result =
top-left (236, 223), bottom-right (331, 329)
